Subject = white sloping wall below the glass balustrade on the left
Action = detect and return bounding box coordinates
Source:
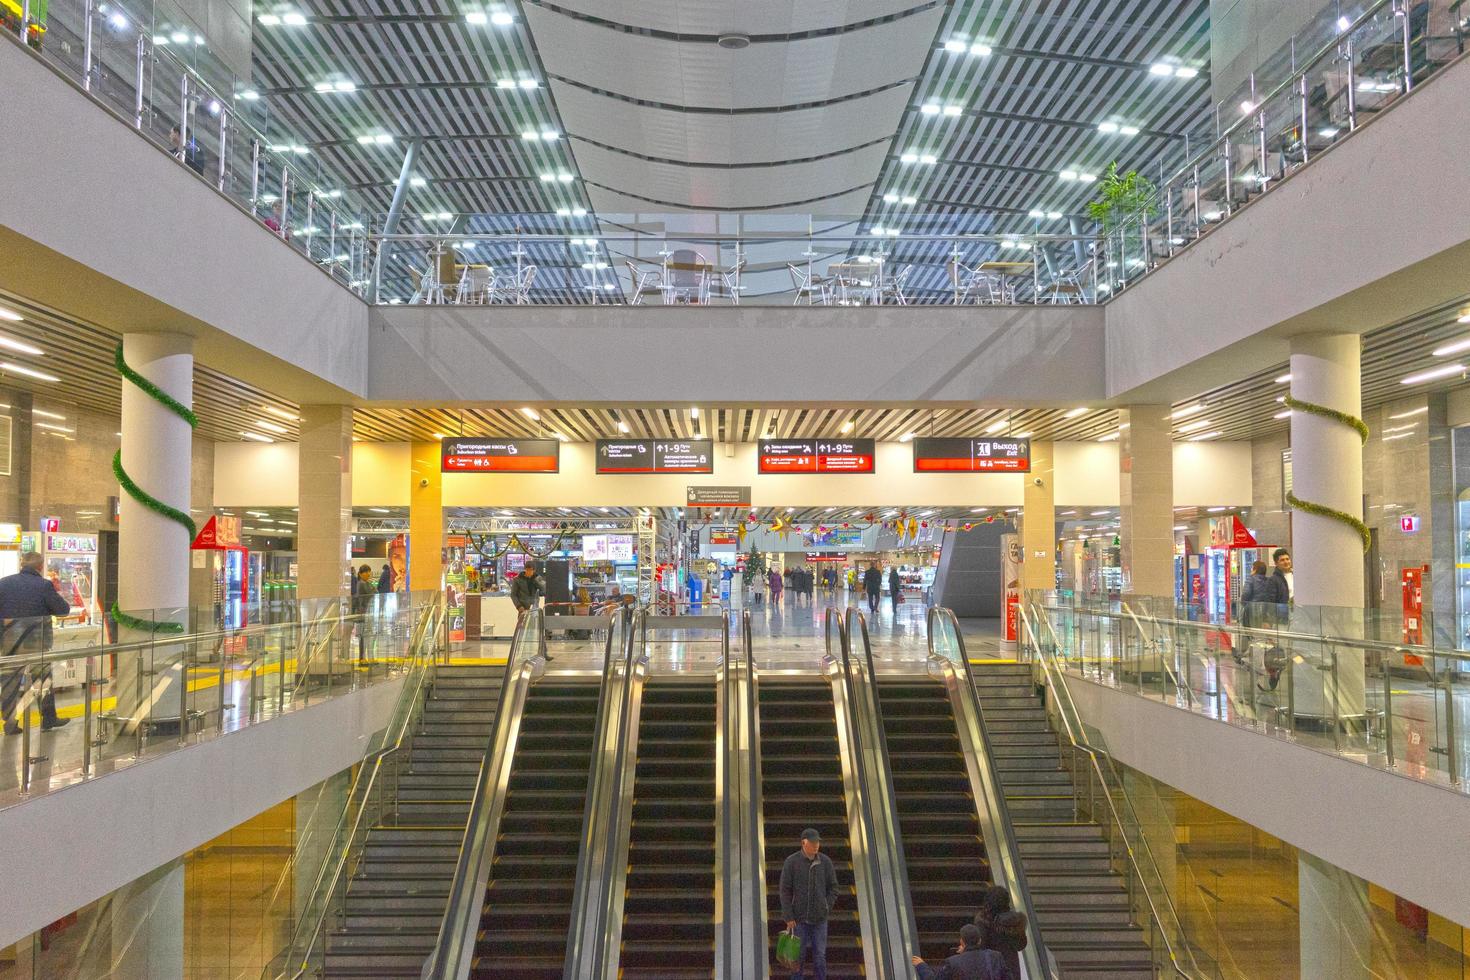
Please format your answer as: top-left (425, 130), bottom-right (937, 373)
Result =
top-left (0, 680), bottom-right (403, 946)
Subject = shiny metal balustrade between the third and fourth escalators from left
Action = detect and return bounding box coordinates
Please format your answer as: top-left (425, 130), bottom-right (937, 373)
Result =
top-left (826, 608), bottom-right (917, 977)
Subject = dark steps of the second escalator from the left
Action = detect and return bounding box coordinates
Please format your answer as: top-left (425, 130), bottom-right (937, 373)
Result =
top-left (620, 680), bottom-right (717, 980)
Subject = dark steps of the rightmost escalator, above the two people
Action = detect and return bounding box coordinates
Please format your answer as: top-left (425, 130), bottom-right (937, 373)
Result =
top-left (878, 679), bottom-right (991, 964)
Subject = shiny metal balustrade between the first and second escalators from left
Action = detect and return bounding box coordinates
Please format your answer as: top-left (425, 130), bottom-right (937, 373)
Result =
top-left (562, 608), bottom-right (648, 980)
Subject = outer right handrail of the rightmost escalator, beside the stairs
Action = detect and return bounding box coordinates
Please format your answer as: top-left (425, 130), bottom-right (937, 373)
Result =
top-left (928, 605), bottom-right (1058, 980)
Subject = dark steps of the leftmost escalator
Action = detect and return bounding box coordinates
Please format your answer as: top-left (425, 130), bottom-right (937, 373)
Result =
top-left (470, 680), bottom-right (598, 980)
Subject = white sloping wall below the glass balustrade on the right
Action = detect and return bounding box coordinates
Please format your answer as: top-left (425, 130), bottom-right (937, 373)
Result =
top-left (1067, 677), bottom-right (1470, 923)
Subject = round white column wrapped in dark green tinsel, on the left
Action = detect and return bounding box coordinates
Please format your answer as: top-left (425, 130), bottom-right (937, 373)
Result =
top-left (116, 334), bottom-right (192, 720)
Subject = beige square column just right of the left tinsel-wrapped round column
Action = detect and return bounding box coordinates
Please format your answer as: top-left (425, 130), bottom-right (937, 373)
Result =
top-left (295, 406), bottom-right (353, 599)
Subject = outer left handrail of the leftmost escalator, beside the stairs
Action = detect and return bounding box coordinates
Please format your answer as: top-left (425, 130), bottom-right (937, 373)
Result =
top-left (420, 608), bottom-right (552, 980)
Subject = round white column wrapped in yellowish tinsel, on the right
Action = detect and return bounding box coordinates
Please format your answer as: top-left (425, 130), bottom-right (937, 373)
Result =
top-left (1291, 334), bottom-right (1364, 717)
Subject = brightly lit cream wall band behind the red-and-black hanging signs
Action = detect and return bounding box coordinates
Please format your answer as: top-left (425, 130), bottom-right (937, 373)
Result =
top-left (215, 442), bottom-right (1251, 507)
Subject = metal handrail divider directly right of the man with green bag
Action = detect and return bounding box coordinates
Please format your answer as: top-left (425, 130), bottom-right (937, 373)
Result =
top-left (826, 608), bottom-right (919, 977)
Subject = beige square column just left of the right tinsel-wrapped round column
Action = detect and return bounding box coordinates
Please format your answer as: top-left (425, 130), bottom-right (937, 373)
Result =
top-left (1117, 406), bottom-right (1175, 598)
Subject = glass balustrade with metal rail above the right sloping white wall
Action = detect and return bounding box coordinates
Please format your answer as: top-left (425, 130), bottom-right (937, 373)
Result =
top-left (1028, 592), bottom-right (1470, 792)
